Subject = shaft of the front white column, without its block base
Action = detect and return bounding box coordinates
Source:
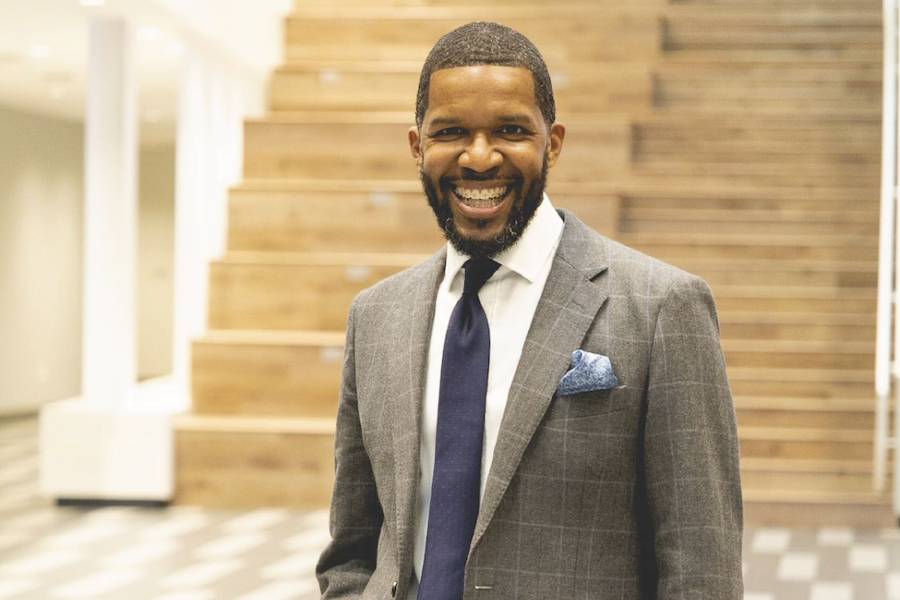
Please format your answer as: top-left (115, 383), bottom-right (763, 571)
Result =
top-left (82, 17), bottom-right (138, 405)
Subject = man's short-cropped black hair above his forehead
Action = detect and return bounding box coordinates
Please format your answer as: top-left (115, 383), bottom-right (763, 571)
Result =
top-left (416, 21), bottom-right (556, 127)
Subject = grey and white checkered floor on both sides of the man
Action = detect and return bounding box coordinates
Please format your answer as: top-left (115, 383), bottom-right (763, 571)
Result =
top-left (0, 419), bottom-right (900, 600)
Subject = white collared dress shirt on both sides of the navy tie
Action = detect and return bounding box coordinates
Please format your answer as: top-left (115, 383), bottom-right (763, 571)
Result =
top-left (407, 195), bottom-right (563, 600)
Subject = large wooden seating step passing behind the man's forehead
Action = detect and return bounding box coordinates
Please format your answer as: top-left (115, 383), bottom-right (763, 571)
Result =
top-left (269, 60), bottom-right (653, 117)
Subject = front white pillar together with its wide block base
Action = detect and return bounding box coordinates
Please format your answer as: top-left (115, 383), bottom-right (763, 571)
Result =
top-left (39, 16), bottom-right (178, 501)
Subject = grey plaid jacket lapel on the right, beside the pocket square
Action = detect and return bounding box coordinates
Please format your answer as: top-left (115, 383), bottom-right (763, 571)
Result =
top-left (471, 211), bottom-right (608, 548)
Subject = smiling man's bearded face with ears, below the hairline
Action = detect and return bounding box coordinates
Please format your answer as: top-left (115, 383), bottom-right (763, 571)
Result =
top-left (409, 65), bottom-right (565, 256)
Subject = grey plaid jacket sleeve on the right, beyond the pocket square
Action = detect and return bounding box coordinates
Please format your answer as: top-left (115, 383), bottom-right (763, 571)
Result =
top-left (644, 276), bottom-right (743, 600)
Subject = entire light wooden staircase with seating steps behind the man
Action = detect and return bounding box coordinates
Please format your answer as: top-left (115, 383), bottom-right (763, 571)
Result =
top-left (176, 0), bottom-right (893, 525)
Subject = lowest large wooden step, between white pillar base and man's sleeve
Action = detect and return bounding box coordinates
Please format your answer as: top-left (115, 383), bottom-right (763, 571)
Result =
top-left (174, 415), bottom-right (334, 509)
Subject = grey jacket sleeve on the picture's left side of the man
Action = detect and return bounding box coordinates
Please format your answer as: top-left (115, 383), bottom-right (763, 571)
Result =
top-left (316, 298), bottom-right (384, 600)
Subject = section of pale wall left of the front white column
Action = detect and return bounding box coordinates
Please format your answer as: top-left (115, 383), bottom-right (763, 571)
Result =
top-left (0, 108), bottom-right (83, 413)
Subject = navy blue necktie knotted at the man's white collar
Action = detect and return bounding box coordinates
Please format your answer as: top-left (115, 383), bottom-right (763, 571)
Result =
top-left (418, 258), bottom-right (500, 600)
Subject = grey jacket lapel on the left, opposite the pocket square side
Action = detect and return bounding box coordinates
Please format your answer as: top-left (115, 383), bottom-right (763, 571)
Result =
top-left (385, 248), bottom-right (447, 565)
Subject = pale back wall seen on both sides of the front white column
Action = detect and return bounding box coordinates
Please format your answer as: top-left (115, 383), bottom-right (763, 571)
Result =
top-left (0, 106), bottom-right (175, 415)
